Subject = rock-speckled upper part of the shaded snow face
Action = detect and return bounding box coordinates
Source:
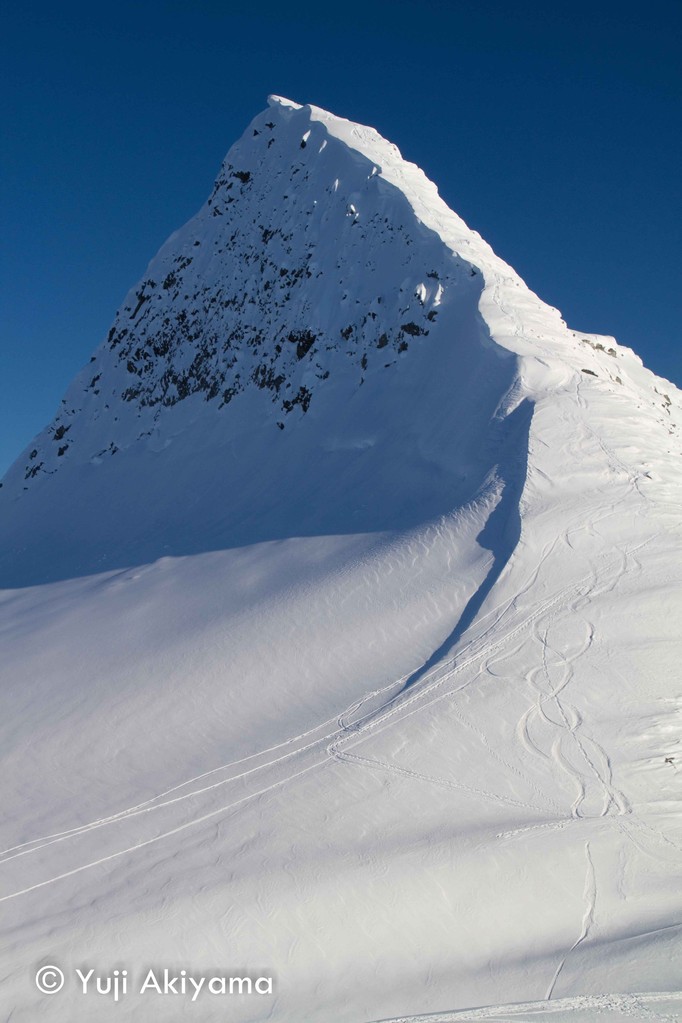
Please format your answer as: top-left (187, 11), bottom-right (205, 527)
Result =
top-left (2, 100), bottom-right (490, 485)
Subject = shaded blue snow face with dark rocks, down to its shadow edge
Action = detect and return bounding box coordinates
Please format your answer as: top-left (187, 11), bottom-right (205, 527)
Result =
top-left (0, 100), bottom-right (537, 584)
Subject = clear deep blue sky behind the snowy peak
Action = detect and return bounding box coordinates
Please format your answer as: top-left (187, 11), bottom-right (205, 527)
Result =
top-left (0, 0), bottom-right (682, 473)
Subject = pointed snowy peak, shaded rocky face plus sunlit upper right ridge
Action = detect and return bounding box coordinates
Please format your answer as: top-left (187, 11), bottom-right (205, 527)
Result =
top-left (0, 96), bottom-right (676, 578)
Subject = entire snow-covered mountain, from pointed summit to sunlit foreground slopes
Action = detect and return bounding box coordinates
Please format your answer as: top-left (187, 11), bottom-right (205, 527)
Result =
top-left (0, 98), bottom-right (682, 1023)
